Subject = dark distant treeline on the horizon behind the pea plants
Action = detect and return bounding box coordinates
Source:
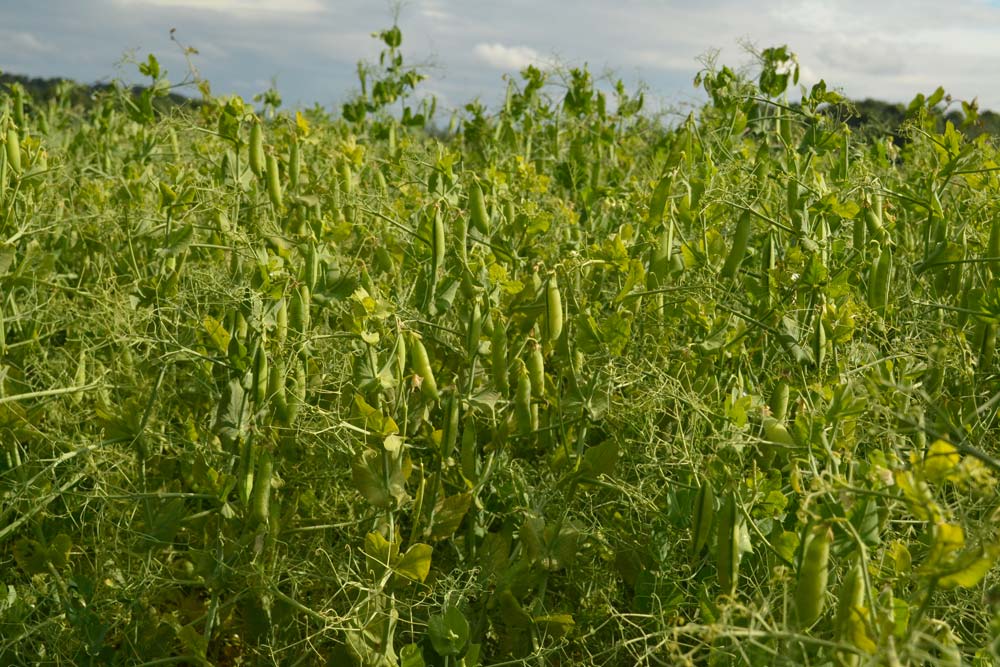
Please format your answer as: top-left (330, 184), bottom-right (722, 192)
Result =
top-left (0, 73), bottom-right (1000, 138)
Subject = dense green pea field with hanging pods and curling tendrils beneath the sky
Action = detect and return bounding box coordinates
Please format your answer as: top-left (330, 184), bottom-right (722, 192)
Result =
top-left (0, 27), bottom-right (1000, 667)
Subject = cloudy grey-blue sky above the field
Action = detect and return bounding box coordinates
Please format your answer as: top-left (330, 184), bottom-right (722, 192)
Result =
top-left (0, 0), bottom-right (1000, 118)
